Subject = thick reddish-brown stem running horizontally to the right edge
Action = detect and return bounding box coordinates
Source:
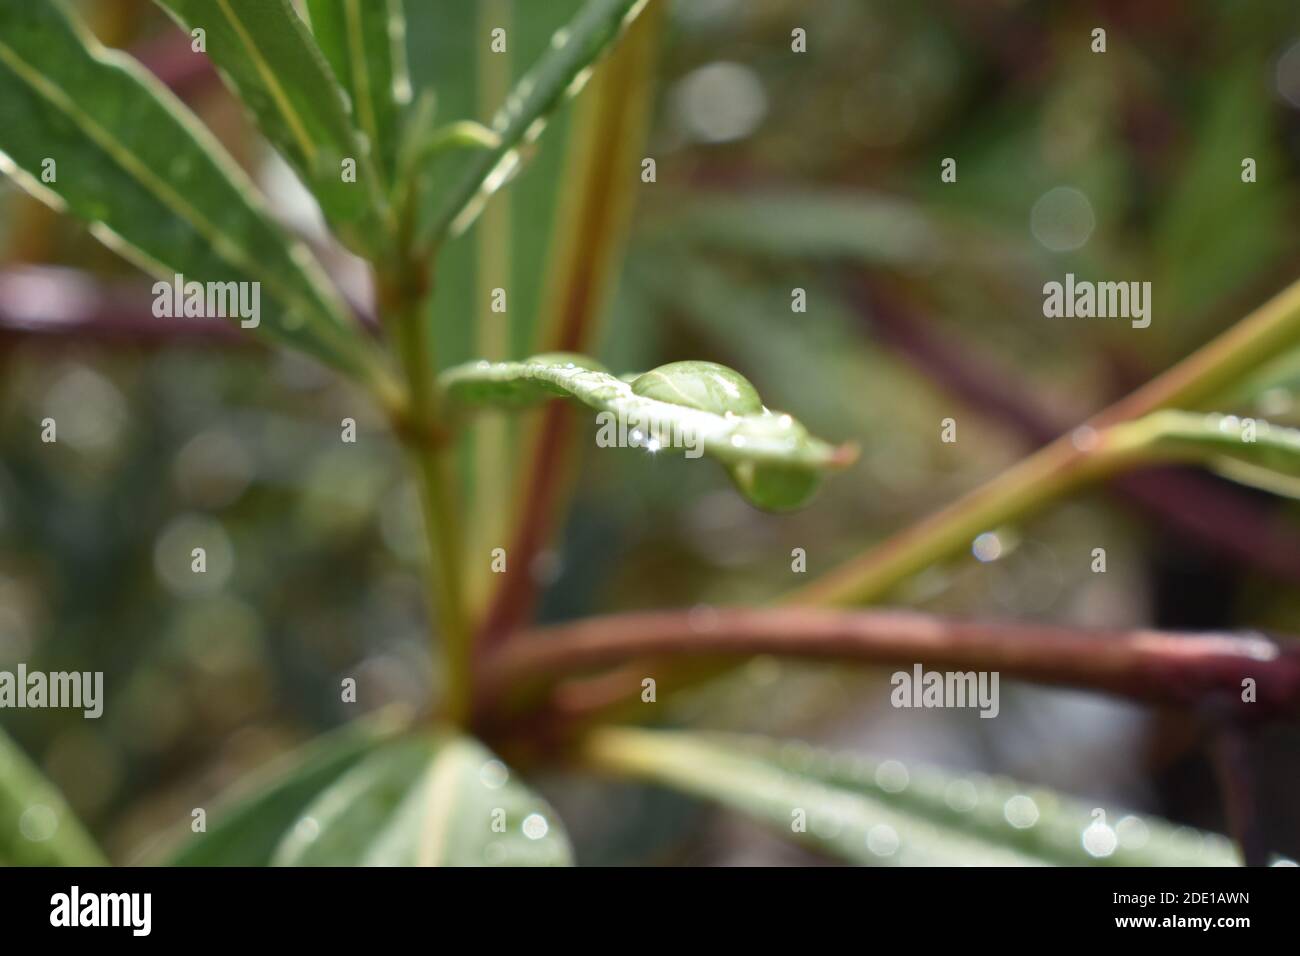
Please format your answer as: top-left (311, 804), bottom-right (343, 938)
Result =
top-left (480, 607), bottom-right (1300, 721)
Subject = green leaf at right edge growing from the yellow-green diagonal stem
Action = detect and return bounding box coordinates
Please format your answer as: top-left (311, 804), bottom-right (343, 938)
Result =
top-left (1099, 411), bottom-right (1300, 498)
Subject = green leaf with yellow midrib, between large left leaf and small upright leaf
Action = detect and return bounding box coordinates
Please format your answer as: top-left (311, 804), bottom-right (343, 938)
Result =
top-left (157, 0), bottom-right (387, 251)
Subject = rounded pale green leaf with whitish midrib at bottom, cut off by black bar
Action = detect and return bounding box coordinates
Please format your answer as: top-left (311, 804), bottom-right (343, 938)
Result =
top-left (274, 735), bottom-right (572, 866)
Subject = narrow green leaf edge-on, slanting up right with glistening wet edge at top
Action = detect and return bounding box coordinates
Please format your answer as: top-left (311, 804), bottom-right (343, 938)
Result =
top-left (420, 0), bottom-right (649, 243)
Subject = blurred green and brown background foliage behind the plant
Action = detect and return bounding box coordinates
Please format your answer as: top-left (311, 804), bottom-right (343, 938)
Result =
top-left (0, 0), bottom-right (1300, 864)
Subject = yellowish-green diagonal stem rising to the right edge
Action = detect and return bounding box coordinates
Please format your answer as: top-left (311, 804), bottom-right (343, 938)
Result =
top-left (785, 282), bottom-right (1300, 605)
